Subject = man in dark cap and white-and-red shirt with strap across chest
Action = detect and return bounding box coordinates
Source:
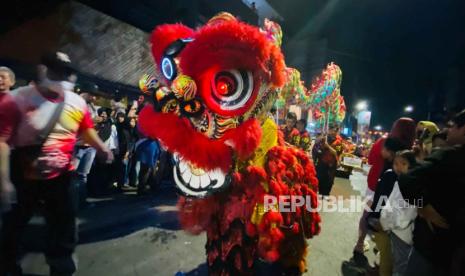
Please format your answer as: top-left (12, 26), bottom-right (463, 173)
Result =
top-left (0, 52), bottom-right (113, 275)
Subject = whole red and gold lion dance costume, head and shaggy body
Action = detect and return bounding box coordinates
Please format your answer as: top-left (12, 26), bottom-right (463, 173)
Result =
top-left (139, 13), bottom-right (320, 275)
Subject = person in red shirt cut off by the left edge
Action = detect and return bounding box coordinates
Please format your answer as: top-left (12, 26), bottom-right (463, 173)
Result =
top-left (0, 67), bottom-right (19, 213)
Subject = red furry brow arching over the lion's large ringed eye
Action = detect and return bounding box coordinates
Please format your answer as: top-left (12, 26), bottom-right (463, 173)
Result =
top-left (180, 21), bottom-right (285, 87)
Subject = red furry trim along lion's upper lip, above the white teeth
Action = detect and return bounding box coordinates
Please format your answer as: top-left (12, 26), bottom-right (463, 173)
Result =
top-left (139, 105), bottom-right (262, 173)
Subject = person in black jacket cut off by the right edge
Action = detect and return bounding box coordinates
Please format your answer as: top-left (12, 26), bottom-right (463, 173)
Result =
top-left (399, 110), bottom-right (465, 275)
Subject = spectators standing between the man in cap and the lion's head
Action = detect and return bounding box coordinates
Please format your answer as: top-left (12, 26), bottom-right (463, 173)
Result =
top-left (73, 87), bottom-right (163, 203)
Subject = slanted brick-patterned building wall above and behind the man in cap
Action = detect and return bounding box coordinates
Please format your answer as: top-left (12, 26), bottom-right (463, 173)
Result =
top-left (0, 1), bottom-right (154, 91)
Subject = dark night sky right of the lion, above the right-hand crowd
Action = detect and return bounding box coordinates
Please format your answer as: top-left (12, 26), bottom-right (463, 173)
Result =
top-left (269, 0), bottom-right (465, 129)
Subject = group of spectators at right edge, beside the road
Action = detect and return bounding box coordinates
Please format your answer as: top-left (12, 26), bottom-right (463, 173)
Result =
top-left (351, 113), bottom-right (465, 276)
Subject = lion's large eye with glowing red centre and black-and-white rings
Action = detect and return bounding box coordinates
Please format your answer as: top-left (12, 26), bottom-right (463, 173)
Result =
top-left (211, 70), bottom-right (254, 111)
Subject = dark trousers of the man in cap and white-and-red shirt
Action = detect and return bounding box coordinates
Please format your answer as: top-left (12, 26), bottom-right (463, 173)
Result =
top-left (0, 173), bottom-right (77, 276)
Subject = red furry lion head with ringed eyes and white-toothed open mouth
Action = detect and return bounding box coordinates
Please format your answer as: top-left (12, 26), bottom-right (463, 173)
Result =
top-left (139, 13), bottom-right (285, 197)
